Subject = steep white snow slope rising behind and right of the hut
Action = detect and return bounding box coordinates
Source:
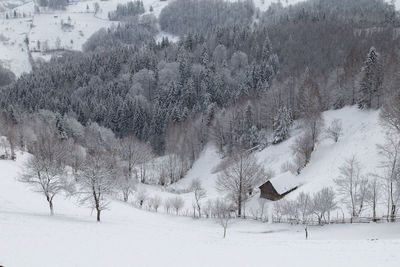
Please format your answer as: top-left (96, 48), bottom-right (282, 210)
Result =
top-left (254, 106), bottom-right (392, 219)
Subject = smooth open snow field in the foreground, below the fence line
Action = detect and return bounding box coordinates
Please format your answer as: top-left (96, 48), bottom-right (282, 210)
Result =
top-left (0, 150), bottom-right (400, 267)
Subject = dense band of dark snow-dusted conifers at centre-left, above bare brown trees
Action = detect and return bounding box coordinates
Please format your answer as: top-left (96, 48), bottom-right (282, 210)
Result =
top-left (1, 18), bottom-right (279, 155)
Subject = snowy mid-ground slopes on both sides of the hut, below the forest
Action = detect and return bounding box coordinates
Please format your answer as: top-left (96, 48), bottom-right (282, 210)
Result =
top-left (147, 106), bottom-right (385, 221)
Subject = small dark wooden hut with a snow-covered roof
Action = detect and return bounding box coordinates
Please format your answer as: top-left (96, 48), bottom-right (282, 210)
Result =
top-left (259, 172), bottom-right (299, 201)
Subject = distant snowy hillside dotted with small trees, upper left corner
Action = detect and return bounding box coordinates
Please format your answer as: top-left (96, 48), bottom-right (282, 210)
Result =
top-left (0, 0), bottom-right (168, 76)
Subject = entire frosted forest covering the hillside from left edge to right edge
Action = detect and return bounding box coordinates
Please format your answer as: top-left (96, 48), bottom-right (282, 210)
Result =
top-left (0, 0), bottom-right (400, 157)
